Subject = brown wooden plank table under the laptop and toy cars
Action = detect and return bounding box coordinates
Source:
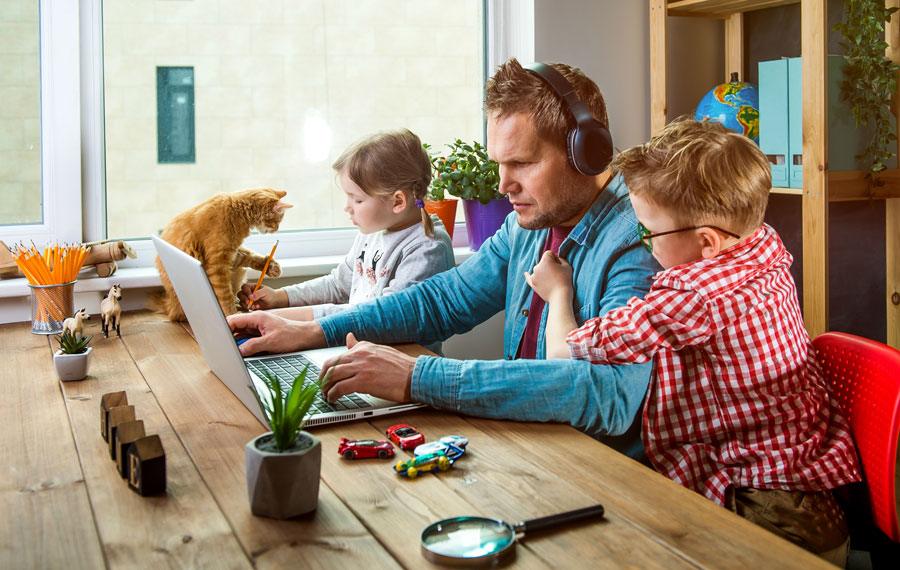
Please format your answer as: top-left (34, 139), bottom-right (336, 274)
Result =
top-left (0, 312), bottom-right (826, 570)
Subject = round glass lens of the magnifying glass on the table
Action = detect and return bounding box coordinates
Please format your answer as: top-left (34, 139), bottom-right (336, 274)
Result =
top-left (422, 517), bottom-right (515, 558)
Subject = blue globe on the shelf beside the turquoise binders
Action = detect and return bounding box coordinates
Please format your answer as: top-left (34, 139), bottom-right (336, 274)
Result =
top-left (694, 73), bottom-right (759, 144)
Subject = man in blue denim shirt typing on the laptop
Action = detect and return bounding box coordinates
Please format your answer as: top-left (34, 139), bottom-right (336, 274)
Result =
top-left (228, 59), bottom-right (658, 455)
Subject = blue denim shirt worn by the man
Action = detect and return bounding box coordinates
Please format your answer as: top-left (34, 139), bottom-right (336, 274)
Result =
top-left (318, 173), bottom-right (659, 449)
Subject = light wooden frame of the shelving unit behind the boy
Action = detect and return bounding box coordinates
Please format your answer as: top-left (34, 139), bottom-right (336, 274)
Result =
top-left (649, 0), bottom-right (900, 347)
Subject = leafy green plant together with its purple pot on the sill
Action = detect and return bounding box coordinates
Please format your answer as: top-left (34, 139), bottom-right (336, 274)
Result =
top-left (431, 139), bottom-right (512, 251)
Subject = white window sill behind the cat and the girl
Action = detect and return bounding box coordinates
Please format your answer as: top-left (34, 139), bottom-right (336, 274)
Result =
top-left (0, 247), bottom-right (474, 323)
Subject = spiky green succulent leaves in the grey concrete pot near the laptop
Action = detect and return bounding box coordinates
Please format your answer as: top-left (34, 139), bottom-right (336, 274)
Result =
top-left (257, 366), bottom-right (319, 451)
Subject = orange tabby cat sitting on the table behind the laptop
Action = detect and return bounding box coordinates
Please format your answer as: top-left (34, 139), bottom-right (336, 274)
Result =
top-left (154, 188), bottom-right (292, 321)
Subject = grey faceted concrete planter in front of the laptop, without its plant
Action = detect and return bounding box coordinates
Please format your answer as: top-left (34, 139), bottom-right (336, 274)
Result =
top-left (244, 431), bottom-right (322, 519)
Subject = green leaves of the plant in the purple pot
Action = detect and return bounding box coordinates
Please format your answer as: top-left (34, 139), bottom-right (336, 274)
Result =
top-left (426, 139), bottom-right (504, 204)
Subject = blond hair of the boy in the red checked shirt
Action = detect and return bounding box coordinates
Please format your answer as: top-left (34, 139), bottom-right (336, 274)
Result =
top-left (612, 117), bottom-right (772, 235)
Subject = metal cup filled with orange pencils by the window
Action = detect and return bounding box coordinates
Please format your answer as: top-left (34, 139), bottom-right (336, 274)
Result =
top-left (11, 242), bottom-right (89, 334)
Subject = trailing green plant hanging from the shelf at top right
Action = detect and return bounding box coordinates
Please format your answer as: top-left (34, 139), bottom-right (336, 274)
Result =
top-left (834, 0), bottom-right (900, 191)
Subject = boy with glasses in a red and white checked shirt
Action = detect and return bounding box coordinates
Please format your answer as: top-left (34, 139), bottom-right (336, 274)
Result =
top-left (525, 120), bottom-right (860, 566)
